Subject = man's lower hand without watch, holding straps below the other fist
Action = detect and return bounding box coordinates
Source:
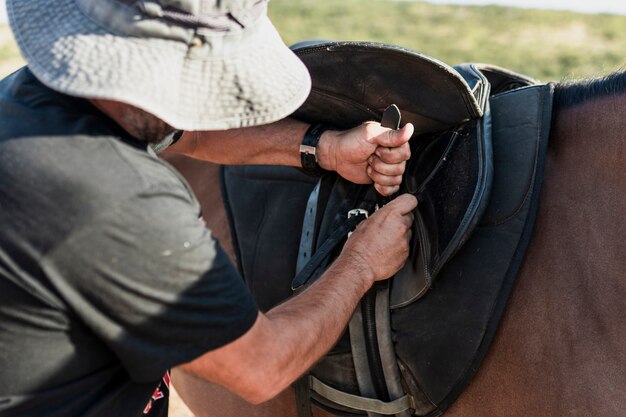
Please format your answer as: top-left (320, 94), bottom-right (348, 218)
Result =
top-left (341, 194), bottom-right (417, 281)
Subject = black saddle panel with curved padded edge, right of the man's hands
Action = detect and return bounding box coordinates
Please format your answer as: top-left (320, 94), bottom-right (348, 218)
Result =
top-left (391, 106), bottom-right (493, 308)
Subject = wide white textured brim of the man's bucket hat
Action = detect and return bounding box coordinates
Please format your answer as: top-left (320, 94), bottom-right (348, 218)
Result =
top-left (7, 0), bottom-right (311, 130)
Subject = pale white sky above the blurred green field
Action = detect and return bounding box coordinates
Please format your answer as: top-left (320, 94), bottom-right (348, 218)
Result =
top-left (0, 0), bottom-right (626, 23)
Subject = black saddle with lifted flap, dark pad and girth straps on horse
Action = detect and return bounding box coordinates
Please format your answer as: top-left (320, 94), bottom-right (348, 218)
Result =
top-left (223, 42), bottom-right (553, 417)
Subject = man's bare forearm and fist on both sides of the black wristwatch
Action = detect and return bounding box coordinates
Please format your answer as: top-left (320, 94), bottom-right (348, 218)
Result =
top-left (163, 119), bottom-right (413, 195)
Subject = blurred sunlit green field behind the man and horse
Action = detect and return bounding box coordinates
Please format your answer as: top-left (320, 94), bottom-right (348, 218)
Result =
top-left (0, 0), bottom-right (626, 81)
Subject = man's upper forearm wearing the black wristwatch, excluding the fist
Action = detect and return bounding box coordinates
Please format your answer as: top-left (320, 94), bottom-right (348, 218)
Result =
top-left (168, 119), bottom-right (330, 167)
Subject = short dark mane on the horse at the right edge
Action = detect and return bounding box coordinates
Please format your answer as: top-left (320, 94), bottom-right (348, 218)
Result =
top-left (554, 69), bottom-right (626, 108)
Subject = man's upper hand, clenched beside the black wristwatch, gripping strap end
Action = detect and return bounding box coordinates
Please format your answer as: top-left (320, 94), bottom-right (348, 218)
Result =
top-left (318, 122), bottom-right (413, 195)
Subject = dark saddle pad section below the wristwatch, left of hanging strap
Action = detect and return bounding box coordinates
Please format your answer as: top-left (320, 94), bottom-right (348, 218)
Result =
top-left (221, 165), bottom-right (317, 311)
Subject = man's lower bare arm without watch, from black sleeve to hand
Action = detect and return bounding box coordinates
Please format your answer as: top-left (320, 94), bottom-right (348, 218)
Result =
top-left (172, 195), bottom-right (417, 403)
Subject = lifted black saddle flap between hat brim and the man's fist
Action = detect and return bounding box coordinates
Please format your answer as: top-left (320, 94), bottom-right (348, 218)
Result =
top-left (292, 41), bottom-right (486, 135)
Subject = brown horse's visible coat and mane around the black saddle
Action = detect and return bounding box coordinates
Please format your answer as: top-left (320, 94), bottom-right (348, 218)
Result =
top-left (169, 72), bottom-right (626, 417)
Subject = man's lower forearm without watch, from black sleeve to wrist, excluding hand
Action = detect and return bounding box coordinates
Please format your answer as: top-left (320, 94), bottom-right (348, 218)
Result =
top-left (176, 250), bottom-right (374, 403)
